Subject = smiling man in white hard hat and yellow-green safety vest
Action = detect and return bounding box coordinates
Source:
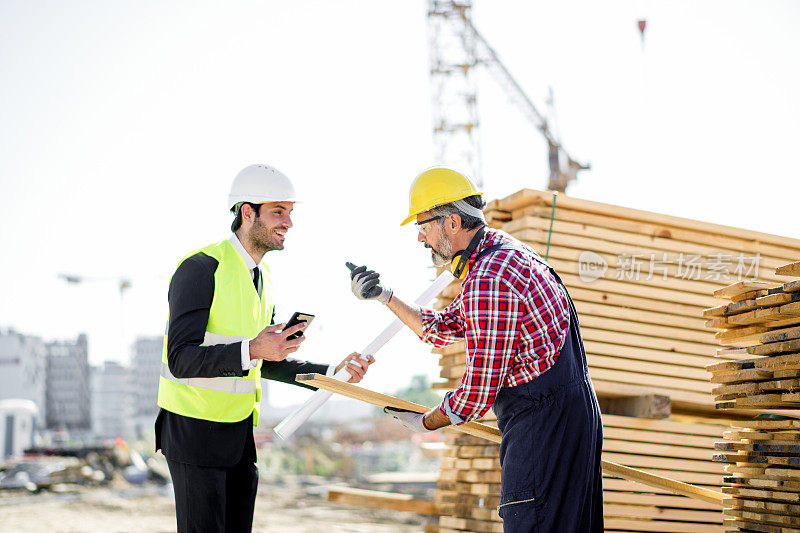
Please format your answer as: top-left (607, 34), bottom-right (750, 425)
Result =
top-left (156, 165), bottom-right (372, 532)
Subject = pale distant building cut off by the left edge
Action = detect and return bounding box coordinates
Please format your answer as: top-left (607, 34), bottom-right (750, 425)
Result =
top-left (0, 330), bottom-right (47, 423)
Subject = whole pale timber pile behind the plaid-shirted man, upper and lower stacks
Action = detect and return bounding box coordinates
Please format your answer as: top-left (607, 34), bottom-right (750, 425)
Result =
top-left (434, 190), bottom-right (800, 533)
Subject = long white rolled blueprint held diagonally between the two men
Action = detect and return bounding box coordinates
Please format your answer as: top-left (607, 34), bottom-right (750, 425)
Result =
top-left (274, 270), bottom-right (455, 440)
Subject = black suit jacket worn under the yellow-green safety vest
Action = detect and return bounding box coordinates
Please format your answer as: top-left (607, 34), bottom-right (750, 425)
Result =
top-left (156, 253), bottom-right (328, 467)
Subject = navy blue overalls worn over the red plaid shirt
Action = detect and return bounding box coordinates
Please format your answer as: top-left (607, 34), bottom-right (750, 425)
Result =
top-left (492, 268), bottom-right (603, 533)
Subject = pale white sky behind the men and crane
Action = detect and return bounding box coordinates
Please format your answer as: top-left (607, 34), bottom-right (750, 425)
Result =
top-left (0, 0), bottom-right (800, 405)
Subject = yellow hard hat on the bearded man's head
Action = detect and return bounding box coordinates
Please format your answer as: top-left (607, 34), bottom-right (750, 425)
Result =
top-left (400, 167), bottom-right (483, 226)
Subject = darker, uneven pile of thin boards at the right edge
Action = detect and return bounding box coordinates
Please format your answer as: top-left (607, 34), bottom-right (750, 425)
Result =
top-left (706, 263), bottom-right (800, 533)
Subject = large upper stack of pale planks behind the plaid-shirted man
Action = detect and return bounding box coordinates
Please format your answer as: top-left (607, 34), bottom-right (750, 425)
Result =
top-left (437, 190), bottom-right (800, 416)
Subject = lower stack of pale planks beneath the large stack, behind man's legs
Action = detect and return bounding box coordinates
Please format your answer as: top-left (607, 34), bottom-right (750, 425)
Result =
top-left (435, 415), bottom-right (728, 533)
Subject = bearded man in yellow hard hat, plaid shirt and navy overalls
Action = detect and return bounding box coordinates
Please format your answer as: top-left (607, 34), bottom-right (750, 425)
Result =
top-left (351, 167), bottom-right (603, 533)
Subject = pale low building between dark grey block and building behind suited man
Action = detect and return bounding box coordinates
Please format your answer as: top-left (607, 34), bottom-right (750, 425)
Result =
top-left (91, 361), bottom-right (134, 438)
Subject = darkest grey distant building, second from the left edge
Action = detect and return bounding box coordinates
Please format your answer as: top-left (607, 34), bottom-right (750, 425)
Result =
top-left (45, 334), bottom-right (92, 430)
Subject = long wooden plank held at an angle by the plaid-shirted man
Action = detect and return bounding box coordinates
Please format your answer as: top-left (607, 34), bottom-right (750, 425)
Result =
top-left (296, 374), bottom-right (725, 505)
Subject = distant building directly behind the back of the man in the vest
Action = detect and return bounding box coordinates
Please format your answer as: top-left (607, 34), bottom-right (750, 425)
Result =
top-left (131, 336), bottom-right (164, 420)
